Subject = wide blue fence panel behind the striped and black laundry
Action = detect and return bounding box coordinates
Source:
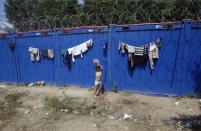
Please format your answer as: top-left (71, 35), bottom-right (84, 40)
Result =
top-left (112, 24), bottom-right (181, 94)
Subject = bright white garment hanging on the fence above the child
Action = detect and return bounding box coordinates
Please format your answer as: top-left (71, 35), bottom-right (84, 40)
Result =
top-left (68, 39), bottom-right (93, 62)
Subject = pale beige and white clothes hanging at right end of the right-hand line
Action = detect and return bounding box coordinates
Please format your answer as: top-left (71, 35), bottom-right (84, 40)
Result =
top-left (148, 38), bottom-right (162, 70)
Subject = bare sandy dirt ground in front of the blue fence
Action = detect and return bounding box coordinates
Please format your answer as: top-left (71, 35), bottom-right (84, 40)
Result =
top-left (0, 84), bottom-right (201, 131)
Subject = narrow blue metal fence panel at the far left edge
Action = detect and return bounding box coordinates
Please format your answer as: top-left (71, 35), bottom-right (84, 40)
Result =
top-left (0, 38), bottom-right (17, 83)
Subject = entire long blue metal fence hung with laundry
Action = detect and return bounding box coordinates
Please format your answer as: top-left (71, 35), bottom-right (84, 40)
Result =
top-left (0, 21), bottom-right (201, 95)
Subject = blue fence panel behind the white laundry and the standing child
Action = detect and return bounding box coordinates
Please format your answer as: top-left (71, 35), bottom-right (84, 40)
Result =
top-left (58, 29), bottom-right (108, 87)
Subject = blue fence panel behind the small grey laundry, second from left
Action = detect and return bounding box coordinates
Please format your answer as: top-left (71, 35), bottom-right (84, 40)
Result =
top-left (15, 32), bottom-right (55, 83)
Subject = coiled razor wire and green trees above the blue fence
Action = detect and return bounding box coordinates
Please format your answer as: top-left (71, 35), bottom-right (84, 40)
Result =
top-left (2, 0), bottom-right (201, 31)
